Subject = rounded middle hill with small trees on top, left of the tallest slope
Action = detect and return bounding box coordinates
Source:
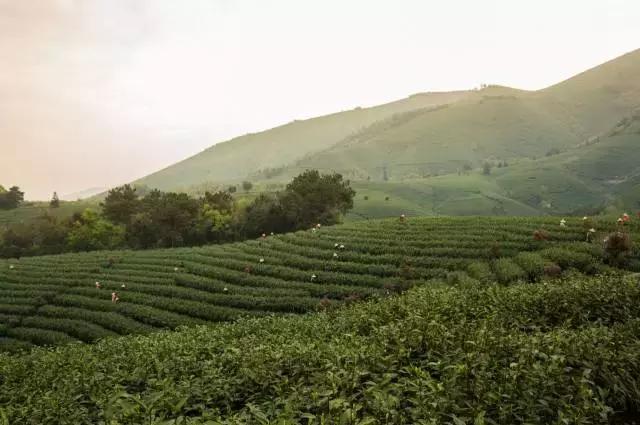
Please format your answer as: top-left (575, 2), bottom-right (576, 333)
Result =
top-left (297, 89), bottom-right (581, 180)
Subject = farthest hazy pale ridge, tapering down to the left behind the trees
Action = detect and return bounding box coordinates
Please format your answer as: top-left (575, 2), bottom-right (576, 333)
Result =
top-left (136, 91), bottom-right (473, 190)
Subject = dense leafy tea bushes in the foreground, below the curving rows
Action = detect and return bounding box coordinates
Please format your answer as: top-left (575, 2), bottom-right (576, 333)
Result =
top-left (0, 275), bottom-right (640, 424)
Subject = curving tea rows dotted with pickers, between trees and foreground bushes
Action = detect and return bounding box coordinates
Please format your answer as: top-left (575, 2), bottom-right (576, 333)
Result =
top-left (0, 218), bottom-right (636, 350)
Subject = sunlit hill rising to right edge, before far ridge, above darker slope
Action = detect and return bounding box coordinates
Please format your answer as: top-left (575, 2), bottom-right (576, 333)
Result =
top-left (296, 50), bottom-right (640, 179)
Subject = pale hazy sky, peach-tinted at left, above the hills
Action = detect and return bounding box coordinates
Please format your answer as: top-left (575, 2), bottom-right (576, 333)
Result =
top-left (0, 0), bottom-right (640, 199)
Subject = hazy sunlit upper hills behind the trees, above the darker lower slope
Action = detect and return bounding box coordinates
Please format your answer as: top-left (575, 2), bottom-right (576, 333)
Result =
top-left (137, 50), bottom-right (640, 196)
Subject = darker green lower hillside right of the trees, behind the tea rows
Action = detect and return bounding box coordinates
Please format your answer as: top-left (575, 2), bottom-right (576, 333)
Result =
top-left (347, 113), bottom-right (640, 220)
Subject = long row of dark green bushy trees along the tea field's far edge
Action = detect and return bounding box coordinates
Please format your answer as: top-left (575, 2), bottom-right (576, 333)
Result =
top-left (0, 170), bottom-right (355, 257)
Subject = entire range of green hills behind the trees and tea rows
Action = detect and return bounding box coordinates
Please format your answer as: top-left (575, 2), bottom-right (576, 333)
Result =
top-left (136, 50), bottom-right (640, 216)
